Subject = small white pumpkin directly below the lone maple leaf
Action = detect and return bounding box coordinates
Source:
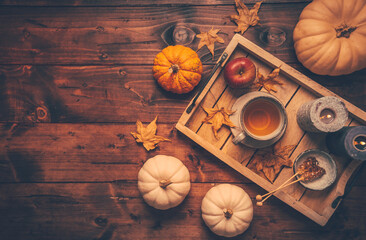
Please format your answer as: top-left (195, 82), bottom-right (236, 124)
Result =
top-left (138, 155), bottom-right (191, 210)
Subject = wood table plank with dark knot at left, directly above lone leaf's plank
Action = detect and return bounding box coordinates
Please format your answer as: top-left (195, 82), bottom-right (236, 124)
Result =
top-left (0, 65), bottom-right (366, 123)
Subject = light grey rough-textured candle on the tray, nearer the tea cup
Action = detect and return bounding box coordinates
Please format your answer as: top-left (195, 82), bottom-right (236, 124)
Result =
top-left (297, 96), bottom-right (348, 132)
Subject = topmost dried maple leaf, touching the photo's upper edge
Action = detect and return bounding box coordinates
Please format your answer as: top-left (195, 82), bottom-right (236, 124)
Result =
top-left (230, 0), bottom-right (263, 34)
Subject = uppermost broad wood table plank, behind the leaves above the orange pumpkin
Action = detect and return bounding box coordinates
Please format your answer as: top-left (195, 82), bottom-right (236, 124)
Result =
top-left (0, 3), bottom-right (306, 65)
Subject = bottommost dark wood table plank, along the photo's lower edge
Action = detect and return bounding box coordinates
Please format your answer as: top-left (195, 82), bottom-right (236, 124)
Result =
top-left (0, 181), bottom-right (366, 240)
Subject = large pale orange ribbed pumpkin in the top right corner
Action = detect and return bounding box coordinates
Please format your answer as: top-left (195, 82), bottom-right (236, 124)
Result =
top-left (293, 0), bottom-right (366, 76)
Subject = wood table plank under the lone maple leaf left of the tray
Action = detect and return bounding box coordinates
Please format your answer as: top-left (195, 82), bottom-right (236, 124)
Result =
top-left (0, 123), bottom-right (248, 182)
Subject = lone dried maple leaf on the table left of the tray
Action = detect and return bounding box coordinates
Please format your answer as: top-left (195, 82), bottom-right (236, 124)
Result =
top-left (131, 116), bottom-right (170, 151)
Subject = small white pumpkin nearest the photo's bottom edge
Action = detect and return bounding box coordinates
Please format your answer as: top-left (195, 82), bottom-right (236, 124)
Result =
top-left (201, 184), bottom-right (253, 237)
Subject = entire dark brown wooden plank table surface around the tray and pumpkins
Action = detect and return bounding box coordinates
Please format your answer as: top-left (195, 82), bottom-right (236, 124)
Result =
top-left (0, 0), bottom-right (366, 240)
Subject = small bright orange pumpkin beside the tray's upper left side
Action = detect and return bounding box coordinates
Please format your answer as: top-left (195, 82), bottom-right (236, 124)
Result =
top-left (153, 45), bottom-right (202, 94)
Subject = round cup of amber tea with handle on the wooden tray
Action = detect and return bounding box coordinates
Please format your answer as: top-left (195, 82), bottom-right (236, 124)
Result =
top-left (233, 92), bottom-right (287, 147)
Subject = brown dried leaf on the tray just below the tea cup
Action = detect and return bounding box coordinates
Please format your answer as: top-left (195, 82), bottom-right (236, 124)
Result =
top-left (248, 144), bottom-right (296, 182)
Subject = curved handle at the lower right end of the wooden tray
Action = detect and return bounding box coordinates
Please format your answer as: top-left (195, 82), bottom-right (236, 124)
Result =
top-left (331, 160), bottom-right (365, 209)
